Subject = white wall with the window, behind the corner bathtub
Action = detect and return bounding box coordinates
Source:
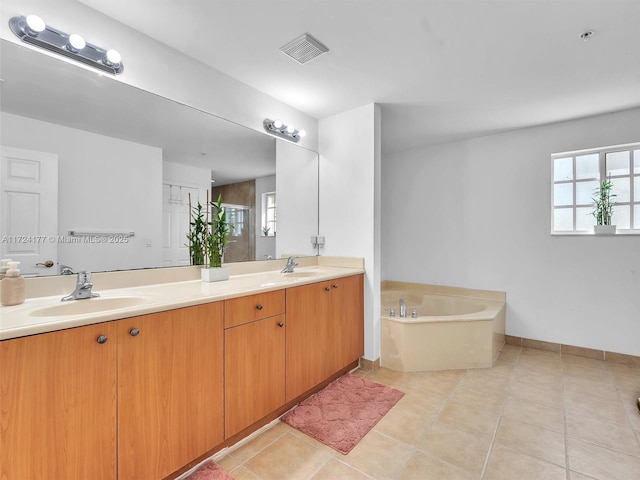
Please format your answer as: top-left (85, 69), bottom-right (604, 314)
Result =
top-left (382, 109), bottom-right (640, 355)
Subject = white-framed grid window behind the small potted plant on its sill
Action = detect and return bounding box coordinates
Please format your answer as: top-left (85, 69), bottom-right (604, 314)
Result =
top-left (551, 143), bottom-right (640, 234)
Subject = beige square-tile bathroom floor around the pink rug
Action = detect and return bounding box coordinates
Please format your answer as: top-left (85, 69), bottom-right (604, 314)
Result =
top-left (218, 345), bottom-right (640, 480)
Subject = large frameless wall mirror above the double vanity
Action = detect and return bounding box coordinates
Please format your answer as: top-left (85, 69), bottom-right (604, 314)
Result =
top-left (0, 40), bottom-right (318, 275)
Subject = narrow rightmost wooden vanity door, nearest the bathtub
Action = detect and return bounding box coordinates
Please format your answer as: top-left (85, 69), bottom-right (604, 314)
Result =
top-left (331, 275), bottom-right (364, 373)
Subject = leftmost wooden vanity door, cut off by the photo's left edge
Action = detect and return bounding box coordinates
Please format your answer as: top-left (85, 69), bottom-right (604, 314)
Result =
top-left (0, 322), bottom-right (117, 480)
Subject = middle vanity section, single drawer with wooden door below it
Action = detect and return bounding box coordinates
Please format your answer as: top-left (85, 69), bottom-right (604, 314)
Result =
top-left (224, 290), bottom-right (286, 438)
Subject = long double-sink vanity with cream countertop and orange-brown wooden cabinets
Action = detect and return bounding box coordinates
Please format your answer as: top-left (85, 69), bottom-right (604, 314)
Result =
top-left (0, 257), bottom-right (364, 480)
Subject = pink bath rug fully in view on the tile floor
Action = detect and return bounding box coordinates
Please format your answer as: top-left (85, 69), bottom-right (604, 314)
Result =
top-left (281, 373), bottom-right (404, 455)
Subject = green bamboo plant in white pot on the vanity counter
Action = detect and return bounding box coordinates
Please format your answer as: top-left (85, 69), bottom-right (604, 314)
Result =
top-left (187, 192), bottom-right (233, 282)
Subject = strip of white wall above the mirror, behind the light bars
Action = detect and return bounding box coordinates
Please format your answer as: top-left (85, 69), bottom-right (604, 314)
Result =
top-left (0, 0), bottom-right (318, 149)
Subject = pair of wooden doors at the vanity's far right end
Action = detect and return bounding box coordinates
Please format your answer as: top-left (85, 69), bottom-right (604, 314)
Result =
top-left (286, 275), bottom-right (364, 401)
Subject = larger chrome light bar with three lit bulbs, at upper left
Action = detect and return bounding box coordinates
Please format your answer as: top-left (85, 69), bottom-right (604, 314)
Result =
top-left (9, 15), bottom-right (124, 75)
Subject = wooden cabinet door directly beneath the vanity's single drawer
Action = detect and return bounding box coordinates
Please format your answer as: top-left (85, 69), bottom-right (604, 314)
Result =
top-left (224, 315), bottom-right (285, 438)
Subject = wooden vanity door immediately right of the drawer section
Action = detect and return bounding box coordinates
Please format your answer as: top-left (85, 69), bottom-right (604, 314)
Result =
top-left (286, 282), bottom-right (334, 401)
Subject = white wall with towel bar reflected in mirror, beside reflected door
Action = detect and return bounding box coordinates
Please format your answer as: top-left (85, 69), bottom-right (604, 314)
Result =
top-left (0, 113), bottom-right (162, 271)
